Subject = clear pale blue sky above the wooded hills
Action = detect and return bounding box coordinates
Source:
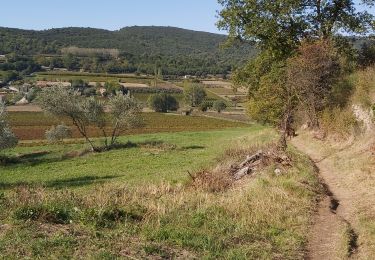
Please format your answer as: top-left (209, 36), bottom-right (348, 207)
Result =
top-left (0, 0), bottom-right (374, 33)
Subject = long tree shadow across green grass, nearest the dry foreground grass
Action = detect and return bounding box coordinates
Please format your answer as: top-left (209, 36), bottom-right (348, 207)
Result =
top-left (0, 175), bottom-right (122, 190)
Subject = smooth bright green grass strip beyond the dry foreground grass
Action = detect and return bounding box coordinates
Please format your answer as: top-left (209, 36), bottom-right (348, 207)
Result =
top-left (0, 126), bottom-right (268, 189)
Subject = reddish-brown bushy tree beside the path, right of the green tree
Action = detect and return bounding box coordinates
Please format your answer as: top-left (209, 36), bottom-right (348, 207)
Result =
top-left (287, 40), bottom-right (341, 128)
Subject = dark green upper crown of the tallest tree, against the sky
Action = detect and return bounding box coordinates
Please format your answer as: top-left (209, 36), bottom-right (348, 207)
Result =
top-left (218, 0), bottom-right (375, 58)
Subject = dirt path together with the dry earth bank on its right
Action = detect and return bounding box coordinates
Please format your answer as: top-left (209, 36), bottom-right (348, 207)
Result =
top-left (292, 133), bottom-right (375, 259)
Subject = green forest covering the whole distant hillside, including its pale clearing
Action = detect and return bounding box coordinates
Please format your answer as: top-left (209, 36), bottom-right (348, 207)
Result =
top-left (0, 26), bottom-right (256, 76)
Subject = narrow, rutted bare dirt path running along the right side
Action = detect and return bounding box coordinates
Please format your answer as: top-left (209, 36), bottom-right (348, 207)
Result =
top-left (292, 138), bottom-right (358, 260)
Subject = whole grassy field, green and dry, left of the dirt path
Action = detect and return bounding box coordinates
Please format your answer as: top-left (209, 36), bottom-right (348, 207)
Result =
top-left (0, 126), bottom-right (320, 259)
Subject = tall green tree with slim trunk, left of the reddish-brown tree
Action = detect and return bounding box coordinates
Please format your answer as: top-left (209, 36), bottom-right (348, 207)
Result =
top-left (218, 0), bottom-right (375, 149)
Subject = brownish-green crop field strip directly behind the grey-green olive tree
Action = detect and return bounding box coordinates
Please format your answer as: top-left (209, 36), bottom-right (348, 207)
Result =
top-left (9, 112), bottom-right (248, 140)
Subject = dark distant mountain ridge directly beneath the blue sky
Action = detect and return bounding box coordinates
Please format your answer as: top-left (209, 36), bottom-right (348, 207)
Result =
top-left (0, 26), bottom-right (256, 74)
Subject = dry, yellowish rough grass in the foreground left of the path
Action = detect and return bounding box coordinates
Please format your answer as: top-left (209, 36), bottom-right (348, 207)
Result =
top-left (0, 139), bottom-right (321, 259)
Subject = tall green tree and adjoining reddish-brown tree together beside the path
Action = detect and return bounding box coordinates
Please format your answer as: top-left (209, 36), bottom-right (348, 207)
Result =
top-left (218, 0), bottom-right (375, 149)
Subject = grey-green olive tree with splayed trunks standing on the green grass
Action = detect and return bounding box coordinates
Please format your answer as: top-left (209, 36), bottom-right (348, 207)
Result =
top-left (39, 86), bottom-right (142, 151)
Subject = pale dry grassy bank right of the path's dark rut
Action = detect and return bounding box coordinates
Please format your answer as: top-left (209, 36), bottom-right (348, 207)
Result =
top-left (298, 132), bottom-right (375, 259)
